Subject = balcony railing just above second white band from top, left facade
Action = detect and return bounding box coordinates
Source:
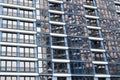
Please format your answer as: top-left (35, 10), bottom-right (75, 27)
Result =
top-left (2, 11), bottom-right (34, 19)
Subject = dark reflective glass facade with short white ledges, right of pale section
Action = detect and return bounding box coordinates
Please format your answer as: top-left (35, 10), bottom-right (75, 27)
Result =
top-left (36, 0), bottom-right (120, 80)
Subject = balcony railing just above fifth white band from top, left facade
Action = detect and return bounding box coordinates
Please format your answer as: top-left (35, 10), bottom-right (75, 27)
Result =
top-left (0, 51), bottom-right (35, 58)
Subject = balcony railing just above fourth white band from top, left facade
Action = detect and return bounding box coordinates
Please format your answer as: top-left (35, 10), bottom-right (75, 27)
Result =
top-left (2, 37), bottom-right (35, 44)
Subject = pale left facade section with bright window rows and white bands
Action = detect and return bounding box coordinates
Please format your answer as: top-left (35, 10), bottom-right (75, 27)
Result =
top-left (0, 0), bottom-right (38, 80)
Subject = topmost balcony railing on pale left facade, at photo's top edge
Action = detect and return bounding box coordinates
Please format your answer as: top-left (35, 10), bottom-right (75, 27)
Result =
top-left (3, 0), bottom-right (34, 7)
